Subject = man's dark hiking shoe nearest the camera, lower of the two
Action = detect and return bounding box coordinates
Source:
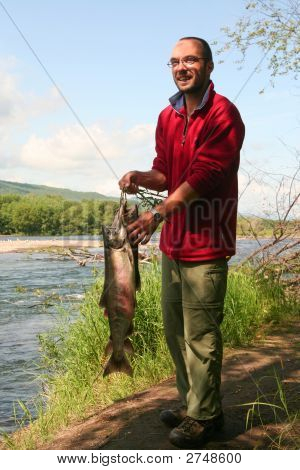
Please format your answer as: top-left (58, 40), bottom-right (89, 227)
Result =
top-left (169, 412), bottom-right (224, 449)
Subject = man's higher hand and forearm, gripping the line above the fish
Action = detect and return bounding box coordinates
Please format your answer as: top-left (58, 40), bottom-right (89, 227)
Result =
top-left (119, 170), bottom-right (167, 194)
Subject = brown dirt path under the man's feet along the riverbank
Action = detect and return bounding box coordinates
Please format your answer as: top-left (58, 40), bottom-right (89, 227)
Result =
top-left (39, 322), bottom-right (300, 450)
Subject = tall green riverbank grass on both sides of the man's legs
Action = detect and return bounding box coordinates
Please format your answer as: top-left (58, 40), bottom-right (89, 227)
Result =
top-left (4, 263), bottom-right (296, 449)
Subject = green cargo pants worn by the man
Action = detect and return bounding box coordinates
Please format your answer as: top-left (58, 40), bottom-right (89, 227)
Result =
top-left (162, 254), bottom-right (228, 420)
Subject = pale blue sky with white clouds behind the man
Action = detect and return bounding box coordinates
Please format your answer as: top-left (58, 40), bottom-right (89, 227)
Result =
top-left (0, 0), bottom-right (300, 215)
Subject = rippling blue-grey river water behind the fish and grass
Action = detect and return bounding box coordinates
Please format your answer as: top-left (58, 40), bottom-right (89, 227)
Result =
top-left (0, 237), bottom-right (264, 432)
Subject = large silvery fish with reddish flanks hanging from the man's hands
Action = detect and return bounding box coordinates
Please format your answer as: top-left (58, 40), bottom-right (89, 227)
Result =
top-left (100, 195), bottom-right (140, 377)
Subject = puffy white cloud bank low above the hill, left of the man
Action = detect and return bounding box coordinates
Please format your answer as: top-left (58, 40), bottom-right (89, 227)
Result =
top-left (20, 123), bottom-right (155, 173)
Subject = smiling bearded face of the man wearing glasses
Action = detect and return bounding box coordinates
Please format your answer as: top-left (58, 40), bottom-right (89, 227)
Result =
top-left (171, 39), bottom-right (213, 94)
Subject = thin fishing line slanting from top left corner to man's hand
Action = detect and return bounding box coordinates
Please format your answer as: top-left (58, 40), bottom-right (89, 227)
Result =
top-left (0, 1), bottom-right (119, 180)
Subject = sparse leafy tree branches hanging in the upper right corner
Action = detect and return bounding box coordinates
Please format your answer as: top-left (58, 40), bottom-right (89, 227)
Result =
top-left (217, 0), bottom-right (300, 83)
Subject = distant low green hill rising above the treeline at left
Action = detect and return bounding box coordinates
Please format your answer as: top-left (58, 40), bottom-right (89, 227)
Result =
top-left (0, 180), bottom-right (118, 201)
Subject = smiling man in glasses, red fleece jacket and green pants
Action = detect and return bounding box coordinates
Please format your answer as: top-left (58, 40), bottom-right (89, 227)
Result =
top-left (119, 37), bottom-right (244, 448)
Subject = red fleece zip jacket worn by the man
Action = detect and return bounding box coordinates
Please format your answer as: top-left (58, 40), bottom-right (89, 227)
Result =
top-left (152, 82), bottom-right (245, 261)
